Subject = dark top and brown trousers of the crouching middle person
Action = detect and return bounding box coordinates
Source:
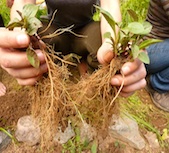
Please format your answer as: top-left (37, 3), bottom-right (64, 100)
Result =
top-left (43, 0), bottom-right (101, 68)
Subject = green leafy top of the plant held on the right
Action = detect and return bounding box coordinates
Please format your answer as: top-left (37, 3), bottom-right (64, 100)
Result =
top-left (95, 6), bottom-right (161, 64)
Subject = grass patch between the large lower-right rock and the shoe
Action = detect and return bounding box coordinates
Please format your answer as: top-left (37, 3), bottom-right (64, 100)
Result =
top-left (120, 94), bottom-right (169, 147)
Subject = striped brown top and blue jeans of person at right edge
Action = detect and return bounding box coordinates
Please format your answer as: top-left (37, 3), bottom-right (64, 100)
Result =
top-left (145, 0), bottom-right (169, 93)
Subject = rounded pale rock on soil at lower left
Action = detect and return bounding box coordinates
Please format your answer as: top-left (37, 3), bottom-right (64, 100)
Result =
top-left (15, 116), bottom-right (40, 146)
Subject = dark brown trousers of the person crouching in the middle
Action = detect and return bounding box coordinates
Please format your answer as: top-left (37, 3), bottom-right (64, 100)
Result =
top-left (40, 22), bottom-right (102, 69)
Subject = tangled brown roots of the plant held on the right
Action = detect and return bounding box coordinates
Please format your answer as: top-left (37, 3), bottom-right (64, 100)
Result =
top-left (71, 59), bottom-right (124, 127)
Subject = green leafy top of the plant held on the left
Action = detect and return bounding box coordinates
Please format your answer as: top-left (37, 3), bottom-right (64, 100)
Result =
top-left (7, 4), bottom-right (42, 68)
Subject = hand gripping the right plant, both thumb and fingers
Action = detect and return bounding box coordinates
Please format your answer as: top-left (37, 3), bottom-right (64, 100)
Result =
top-left (97, 43), bottom-right (146, 97)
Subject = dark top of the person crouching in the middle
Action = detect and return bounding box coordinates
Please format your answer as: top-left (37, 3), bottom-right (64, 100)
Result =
top-left (46, 0), bottom-right (99, 28)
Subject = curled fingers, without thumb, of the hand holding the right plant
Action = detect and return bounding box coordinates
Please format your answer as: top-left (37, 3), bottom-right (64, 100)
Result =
top-left (111, 59), bottom-right (146, 97)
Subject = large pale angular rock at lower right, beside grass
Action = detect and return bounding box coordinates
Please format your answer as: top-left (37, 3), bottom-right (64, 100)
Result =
top-left (109, 115), bottom-right (146, 150)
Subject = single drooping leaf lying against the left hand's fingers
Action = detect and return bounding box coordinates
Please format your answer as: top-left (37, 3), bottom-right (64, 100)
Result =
top-left (26, 47), bottom-right (40, 68)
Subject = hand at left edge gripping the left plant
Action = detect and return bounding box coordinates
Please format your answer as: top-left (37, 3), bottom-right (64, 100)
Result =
top-left (0, 28), bottom-right (47, 85)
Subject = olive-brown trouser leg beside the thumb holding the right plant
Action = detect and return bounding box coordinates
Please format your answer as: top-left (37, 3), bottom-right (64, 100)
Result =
top-left (72, 22), bottom-right (101, 68)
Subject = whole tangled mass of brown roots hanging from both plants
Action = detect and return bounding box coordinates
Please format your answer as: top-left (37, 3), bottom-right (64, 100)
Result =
top-left (26, 32), bottom-right (124, 151)
